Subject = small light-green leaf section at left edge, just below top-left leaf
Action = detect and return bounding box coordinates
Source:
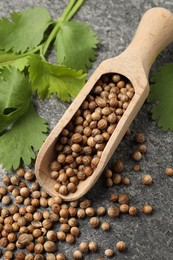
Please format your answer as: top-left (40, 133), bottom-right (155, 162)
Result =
top-left (0, 51), bottom-right (28, 71)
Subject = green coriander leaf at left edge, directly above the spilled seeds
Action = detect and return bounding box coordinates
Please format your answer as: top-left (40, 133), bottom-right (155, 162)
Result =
top-left (0, 104), bottom-right (47, 170)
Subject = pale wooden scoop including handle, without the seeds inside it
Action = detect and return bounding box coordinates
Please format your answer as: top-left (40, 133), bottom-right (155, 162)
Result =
top-left (35, 7), bottom-right (173, 201)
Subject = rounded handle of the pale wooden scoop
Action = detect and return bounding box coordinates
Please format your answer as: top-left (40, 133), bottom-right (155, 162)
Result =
top-left (123, 7), bottom-right (173, 76)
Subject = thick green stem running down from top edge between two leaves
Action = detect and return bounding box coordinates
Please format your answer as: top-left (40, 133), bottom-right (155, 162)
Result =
top-left (40, 0), bottom-right (85, 56)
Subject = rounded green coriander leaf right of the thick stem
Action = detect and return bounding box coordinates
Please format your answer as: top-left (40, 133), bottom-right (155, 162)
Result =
top-left (55, 21), bottom-right (98, 71)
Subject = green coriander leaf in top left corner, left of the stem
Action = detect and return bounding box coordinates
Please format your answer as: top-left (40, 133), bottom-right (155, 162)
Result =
top-left (0, 7), bottom-right (51, 53)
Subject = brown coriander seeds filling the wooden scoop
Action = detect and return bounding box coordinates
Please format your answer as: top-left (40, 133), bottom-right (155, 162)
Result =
top-left (50, 73), bottom-right (135, 195)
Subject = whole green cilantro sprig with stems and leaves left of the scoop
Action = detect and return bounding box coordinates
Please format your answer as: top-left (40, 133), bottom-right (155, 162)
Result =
top-left (0, 0), bottom-right (98, 170)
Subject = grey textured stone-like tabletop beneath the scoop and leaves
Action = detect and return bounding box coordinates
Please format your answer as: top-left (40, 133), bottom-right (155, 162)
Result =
top-left (0, 0), bottom-right (173, 260)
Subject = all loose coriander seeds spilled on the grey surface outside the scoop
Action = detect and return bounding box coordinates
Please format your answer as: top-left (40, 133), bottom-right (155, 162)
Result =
top-left (0, 133), bottom-right (173, 260)
